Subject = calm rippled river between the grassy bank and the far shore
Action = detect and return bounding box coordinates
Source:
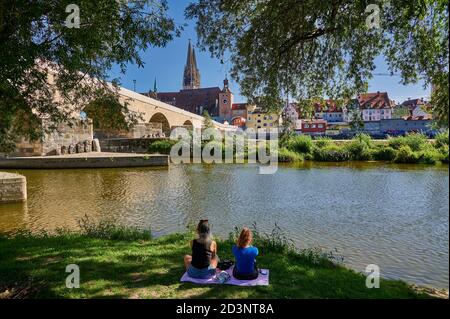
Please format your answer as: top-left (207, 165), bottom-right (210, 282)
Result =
top-left (0, 163), bottom-right (449, 289)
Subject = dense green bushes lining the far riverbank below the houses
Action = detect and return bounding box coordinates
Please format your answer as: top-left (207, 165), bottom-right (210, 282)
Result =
top-left (149, 131), bottom-right (449, 164)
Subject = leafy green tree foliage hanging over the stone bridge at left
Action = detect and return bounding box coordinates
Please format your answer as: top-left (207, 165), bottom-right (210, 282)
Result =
top-left (0, 0), bottom-right (180, 150)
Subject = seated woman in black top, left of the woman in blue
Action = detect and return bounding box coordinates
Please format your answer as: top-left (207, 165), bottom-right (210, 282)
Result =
top-left (184, 220), bottom-right (219, 279)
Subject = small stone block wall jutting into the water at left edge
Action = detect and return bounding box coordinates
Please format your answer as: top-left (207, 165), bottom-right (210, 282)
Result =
top-left (0, 172), bottom-right (27, 204)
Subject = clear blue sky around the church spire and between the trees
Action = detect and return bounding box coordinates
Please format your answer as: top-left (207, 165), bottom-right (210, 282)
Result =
top-left (110, 0), bottom-right (430, 103)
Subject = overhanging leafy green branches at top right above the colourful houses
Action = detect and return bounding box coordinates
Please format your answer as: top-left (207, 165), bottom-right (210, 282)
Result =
top-left (186, 0), bottom-right (449, 121)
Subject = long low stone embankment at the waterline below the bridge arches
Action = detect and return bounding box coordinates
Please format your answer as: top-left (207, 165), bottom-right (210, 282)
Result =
top-left (0, 152), bottom-right (169, 169)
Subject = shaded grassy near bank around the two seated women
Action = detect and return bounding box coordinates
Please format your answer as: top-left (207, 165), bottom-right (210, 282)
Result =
top-left (0, 222), bottom-right (440, 298)
